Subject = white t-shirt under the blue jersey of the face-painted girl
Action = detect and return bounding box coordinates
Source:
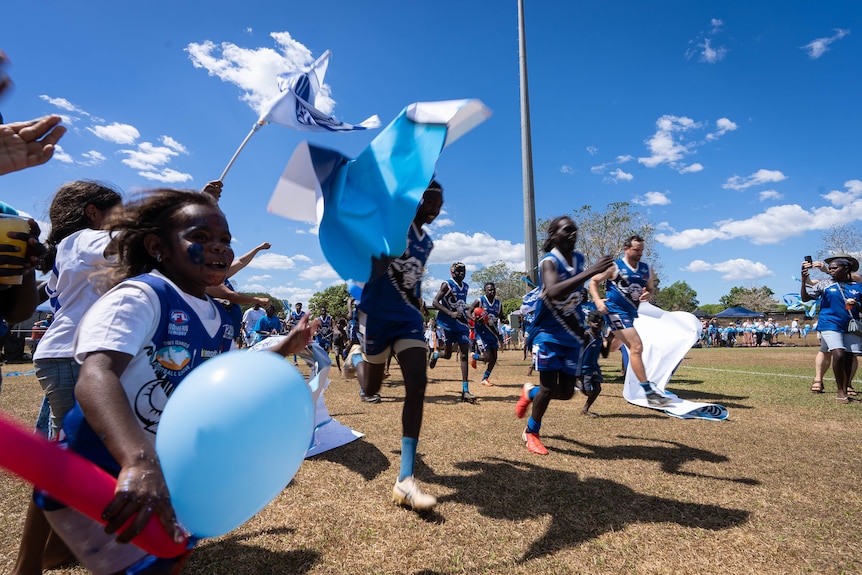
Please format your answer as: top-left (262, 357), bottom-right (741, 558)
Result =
top-left (75, 271), bottom-right (222, 437)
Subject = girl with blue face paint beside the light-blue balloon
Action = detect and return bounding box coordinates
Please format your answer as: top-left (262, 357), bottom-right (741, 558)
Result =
top-left (36, 189), bottom-right (318, 574)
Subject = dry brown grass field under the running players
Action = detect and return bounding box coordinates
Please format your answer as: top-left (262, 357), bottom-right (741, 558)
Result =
top-left (0, 347), bottom-right (862, 575)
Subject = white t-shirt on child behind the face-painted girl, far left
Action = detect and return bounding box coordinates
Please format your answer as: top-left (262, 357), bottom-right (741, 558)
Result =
top-left (33, 229), bottom-right (111, 360)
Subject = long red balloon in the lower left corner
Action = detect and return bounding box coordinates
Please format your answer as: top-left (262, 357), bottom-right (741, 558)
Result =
top-left (0, 412), bottom-right (187, 558)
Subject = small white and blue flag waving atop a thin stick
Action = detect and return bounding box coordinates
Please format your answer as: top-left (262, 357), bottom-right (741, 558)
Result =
top-left (258, 50), bottom-right (380, 132)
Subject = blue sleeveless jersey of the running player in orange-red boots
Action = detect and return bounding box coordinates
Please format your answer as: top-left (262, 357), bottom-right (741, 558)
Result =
top-left (528, 252), bottom-right (589, 347)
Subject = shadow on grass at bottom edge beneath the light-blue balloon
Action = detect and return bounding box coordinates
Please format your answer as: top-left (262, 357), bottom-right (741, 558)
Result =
top-left (185, 527), bottom-right (320, 575)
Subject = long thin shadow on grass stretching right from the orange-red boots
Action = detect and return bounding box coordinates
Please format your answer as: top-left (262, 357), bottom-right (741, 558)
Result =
top-left (548, 435), bottom-right (761, 485)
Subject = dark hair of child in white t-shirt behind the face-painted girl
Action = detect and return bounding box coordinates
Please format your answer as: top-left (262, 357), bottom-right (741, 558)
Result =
top-left (39, 180), bottom-right (123, 273)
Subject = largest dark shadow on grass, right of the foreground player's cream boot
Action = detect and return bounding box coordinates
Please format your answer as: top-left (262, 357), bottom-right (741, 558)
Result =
top-left (423, 458), bottom-right (750, 563)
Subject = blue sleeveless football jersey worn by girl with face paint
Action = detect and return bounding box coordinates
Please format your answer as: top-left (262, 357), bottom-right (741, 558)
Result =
top-left (63, 274), bottom-right (234, 475)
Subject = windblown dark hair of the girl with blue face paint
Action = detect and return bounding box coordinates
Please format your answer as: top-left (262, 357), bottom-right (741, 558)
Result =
top-left (100, 188), bottom-right (218, 286)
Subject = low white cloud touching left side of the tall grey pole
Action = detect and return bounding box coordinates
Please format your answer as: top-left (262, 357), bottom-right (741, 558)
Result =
top-left (428, 232), bottom-right (525, 269)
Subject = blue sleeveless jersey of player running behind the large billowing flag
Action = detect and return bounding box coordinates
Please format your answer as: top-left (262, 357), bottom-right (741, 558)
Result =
top-left (359, 224), bottom-right (434, 321)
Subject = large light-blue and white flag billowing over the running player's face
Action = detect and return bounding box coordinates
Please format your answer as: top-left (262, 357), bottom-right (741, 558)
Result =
top-left (267, 100), bottom-right (491, 282)
